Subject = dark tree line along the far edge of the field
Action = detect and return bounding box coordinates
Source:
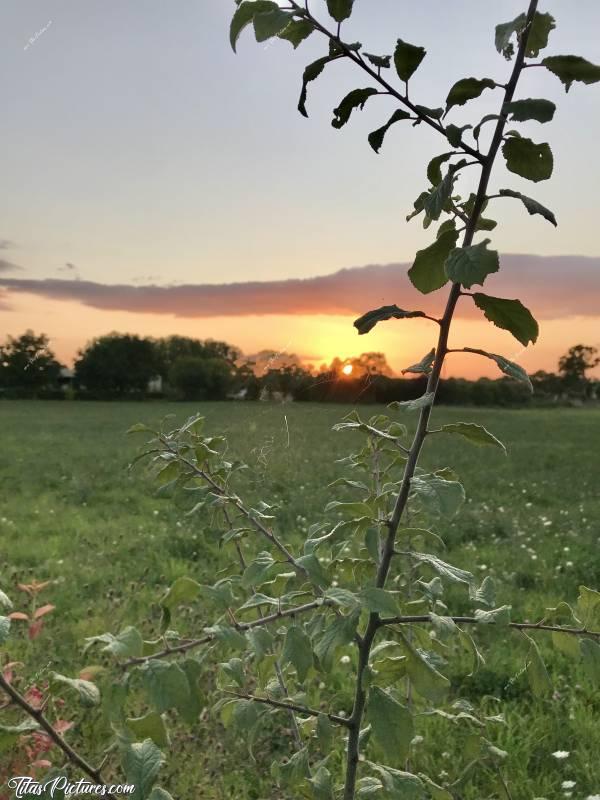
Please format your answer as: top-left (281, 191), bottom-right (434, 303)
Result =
top-left (0, 330), bottom-right (600, 406)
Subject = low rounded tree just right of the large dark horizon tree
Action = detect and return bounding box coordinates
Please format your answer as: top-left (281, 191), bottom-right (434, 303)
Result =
top-left (168, 356), bottom-right (234, 400)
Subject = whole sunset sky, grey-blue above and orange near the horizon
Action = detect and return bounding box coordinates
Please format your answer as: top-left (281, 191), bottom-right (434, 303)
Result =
top-left (0, 0), bottom-right (600, 377)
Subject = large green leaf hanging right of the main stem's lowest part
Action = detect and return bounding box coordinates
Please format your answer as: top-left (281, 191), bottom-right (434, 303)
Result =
top-left (367, 686), bottom-right (414, 765)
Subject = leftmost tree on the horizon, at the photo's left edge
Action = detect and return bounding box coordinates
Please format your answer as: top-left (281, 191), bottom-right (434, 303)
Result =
top-left (0, 330), bottom-right (61, 395)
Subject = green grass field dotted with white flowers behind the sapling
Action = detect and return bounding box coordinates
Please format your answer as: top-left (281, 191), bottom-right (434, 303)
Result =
top-left (0, 402), bottom-right (600, 800)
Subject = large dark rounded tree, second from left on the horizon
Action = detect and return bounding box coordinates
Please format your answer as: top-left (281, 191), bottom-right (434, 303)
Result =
top-left (75, 333), bottom-right (160, 396)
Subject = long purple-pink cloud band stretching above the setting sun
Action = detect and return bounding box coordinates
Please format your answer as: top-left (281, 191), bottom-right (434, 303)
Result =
top-left (0, 255), bottom-right (600, 319)
